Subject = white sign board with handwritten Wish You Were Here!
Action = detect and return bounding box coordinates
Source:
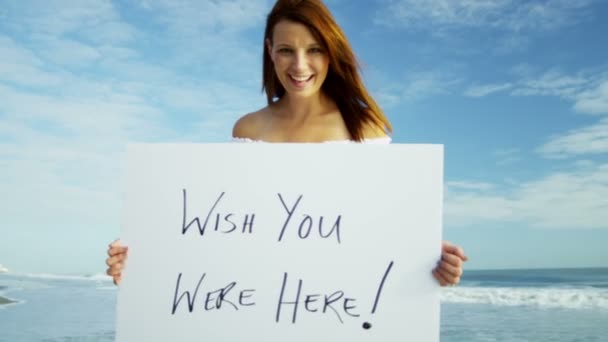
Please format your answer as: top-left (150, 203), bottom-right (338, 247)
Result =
top-left (116, 143), bottom-right (443, 342)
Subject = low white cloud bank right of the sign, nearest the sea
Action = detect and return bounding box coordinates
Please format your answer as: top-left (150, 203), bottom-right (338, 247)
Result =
top-left (445, 164), bottom-right (608, 229)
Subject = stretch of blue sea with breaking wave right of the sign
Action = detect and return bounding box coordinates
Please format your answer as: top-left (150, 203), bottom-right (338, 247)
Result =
top-left (441, 269), bottom-right (608, 342)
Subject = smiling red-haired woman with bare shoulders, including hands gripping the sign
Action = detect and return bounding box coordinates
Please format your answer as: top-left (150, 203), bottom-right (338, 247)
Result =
top-left (106, 0), bottom-right (467, 286)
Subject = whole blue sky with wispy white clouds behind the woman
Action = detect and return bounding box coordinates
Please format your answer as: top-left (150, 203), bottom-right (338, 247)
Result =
top-left (0, 0), bottom-right (608, 274)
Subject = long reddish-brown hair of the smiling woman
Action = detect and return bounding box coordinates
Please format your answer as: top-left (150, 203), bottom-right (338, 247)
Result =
top-left (262, 0), bottom-right (392, 141)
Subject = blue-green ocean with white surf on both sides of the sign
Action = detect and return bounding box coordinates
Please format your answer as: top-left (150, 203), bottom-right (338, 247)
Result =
top-left (0, 268), bottom-right (608, 342)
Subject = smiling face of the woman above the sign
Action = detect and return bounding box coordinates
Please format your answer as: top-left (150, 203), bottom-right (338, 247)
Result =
top-left (266, 20), bottom-right (329, 97)
